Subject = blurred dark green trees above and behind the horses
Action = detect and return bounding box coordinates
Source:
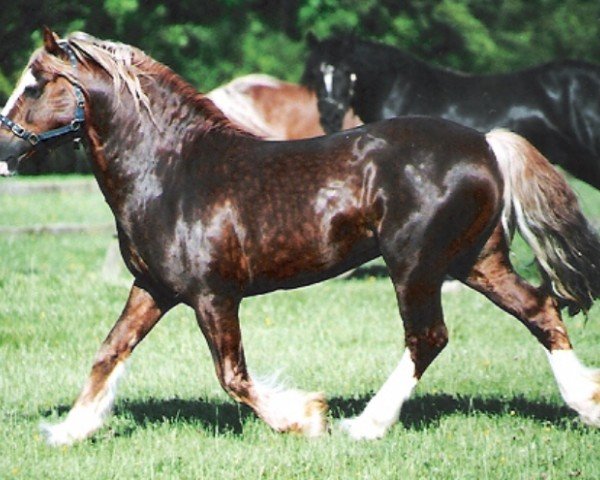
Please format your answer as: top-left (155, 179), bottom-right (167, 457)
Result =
top-left (0, 0), bottom-right (600, 104)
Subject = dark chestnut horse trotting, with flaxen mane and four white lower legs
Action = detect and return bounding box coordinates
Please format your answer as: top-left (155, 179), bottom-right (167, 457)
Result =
top-left (0, 30), bottom-right (600, 445)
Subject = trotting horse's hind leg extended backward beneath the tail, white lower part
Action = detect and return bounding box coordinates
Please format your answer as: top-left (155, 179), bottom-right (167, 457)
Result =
top-left (465, 227), bottom-right (600, 426)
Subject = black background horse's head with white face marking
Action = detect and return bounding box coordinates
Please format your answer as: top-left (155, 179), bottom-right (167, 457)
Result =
top-left (302, 34), bottom-right (357, 133)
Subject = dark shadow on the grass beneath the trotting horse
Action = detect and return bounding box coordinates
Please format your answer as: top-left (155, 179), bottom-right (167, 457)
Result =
top-left (43, 394), bottom-right (586, 436)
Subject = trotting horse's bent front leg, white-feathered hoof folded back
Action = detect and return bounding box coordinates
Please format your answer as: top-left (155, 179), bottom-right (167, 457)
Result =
top-left (196, 295), bottom-right (327, 437)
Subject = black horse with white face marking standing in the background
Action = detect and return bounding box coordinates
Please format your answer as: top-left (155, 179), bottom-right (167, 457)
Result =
top-left (302, 35), bottom-right (600, 189)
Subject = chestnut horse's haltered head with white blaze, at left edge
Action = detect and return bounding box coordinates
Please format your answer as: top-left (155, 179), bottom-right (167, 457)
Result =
top-left (0, 29), bottom-right (84, 176)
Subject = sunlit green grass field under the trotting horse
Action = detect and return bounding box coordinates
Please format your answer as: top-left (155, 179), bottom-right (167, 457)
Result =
top-left (0, 174), bottom-right (600, 480)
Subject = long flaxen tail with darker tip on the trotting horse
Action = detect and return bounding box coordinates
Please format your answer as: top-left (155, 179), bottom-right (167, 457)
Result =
top-left (486, 130), bottom-right (600, 315)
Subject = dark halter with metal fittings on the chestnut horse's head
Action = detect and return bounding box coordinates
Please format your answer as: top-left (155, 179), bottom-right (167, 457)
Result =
top-left (0, 41), bottom-right (85, 147)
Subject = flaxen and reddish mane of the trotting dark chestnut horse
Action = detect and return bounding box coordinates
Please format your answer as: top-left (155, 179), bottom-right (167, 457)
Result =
top-left (35, 32), bottom-right (251, 135)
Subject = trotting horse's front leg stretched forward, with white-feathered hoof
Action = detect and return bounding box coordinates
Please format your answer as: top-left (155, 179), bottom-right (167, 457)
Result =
top-left (42, 284), bottom-right (173, 445)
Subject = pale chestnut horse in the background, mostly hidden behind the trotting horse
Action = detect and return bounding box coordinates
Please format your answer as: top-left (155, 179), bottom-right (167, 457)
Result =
top-left (206, 74), bottom-right (362, 140)
